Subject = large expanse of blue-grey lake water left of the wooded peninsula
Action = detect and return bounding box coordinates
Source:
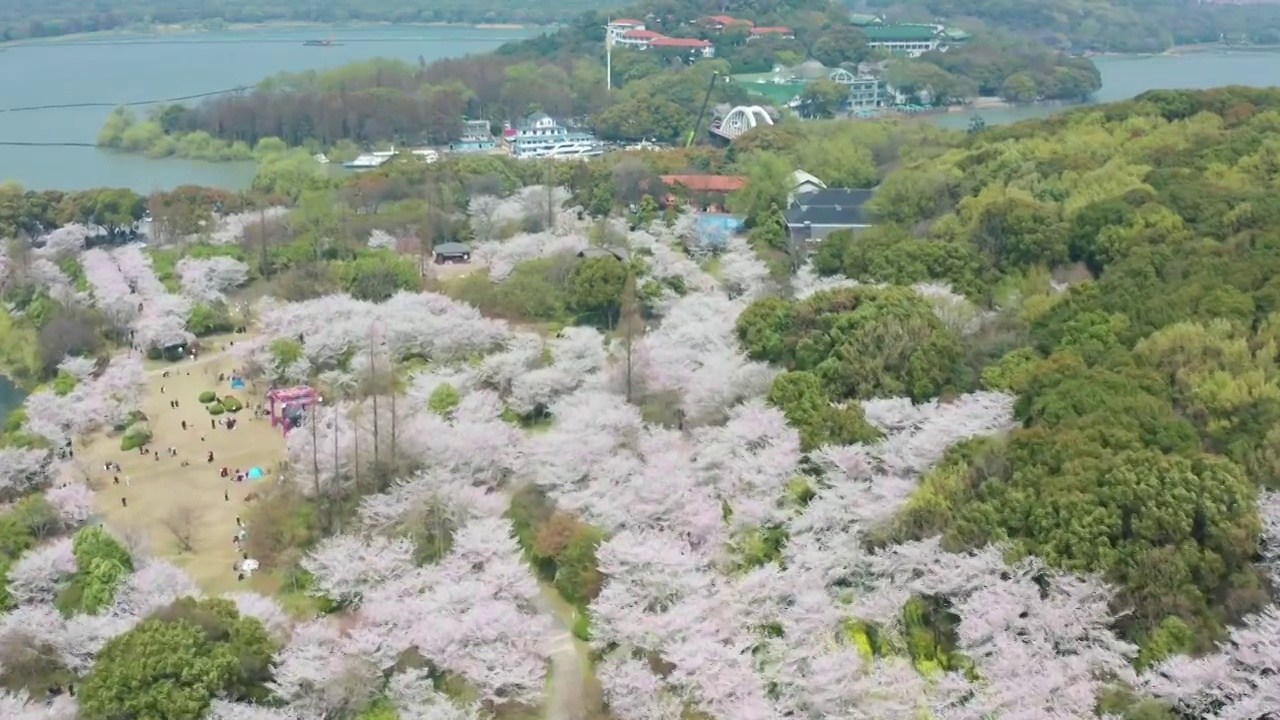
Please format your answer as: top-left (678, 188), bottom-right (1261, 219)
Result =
top-left (0, 26), bottom-right (540, 192)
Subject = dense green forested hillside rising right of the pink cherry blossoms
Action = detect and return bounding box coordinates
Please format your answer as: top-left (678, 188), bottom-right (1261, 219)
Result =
top-left (803, 87), bottom-right (1280, 662)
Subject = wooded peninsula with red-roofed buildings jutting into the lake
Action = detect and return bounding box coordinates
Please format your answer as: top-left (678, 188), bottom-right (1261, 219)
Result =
top-left (99, 0), bottom-right (1101, 160)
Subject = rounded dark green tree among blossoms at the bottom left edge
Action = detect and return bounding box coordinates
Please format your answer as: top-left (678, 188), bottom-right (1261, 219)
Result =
top-left (79, 597), bottom-right (275, 720)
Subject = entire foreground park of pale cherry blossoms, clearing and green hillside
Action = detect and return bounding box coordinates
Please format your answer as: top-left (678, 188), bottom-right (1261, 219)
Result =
top-left (0, 81), bottom-right (1280, 720)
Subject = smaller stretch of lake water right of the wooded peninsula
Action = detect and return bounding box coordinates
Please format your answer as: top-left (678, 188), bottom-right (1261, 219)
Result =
top-left (929, 51), bottom-right (1280, 128)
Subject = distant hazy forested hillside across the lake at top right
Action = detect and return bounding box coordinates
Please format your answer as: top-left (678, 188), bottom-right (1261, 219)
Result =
top-left (859, 0), bottom-right (1280, 53)
